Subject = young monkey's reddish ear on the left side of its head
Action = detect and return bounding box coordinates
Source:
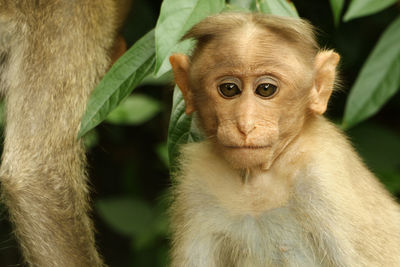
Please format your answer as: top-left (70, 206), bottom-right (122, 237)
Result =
top-left (169, 54), bottom-right (195, 115)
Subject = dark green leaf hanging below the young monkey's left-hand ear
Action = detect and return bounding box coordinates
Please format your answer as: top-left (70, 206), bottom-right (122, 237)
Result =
top-left (167, 86), bottom-right (203, 172)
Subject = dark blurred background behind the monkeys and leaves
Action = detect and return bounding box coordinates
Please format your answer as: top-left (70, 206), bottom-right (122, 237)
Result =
top-left (0, 0), bottom-right (400, 267)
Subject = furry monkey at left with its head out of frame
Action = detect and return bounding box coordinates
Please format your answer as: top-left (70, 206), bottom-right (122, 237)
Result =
top-left (0, 0), bottom-right (130, 267)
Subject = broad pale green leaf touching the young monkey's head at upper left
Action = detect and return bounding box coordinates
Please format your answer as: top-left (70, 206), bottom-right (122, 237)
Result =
top-left (155, 0), bottom-right (225, 77)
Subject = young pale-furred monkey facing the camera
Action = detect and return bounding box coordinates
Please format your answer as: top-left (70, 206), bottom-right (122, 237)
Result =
top-left (170, 13), bottom-right (400, 267)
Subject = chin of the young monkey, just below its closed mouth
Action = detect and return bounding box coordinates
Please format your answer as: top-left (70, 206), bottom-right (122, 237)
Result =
top-left (222, 146), bottom-right (273, 170)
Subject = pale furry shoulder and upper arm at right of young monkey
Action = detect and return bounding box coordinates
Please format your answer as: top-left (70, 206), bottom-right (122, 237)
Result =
top-left (292, 118), bottom-right (400, 266)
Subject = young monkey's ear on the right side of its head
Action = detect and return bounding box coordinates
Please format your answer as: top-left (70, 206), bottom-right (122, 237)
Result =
top-left (310, 50), bottom-right (340, 114)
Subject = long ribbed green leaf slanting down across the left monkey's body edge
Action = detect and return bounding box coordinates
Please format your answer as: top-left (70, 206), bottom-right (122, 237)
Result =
top-left (78, 30), bottom-right (155, 138)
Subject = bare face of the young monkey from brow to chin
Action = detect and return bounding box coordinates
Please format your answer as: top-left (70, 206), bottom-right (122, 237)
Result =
top-left (194, 61), bottom-right (307, 168)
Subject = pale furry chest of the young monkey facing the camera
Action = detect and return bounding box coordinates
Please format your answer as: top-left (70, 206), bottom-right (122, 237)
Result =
top-left (177, 170), bottom-right (323, 267)
